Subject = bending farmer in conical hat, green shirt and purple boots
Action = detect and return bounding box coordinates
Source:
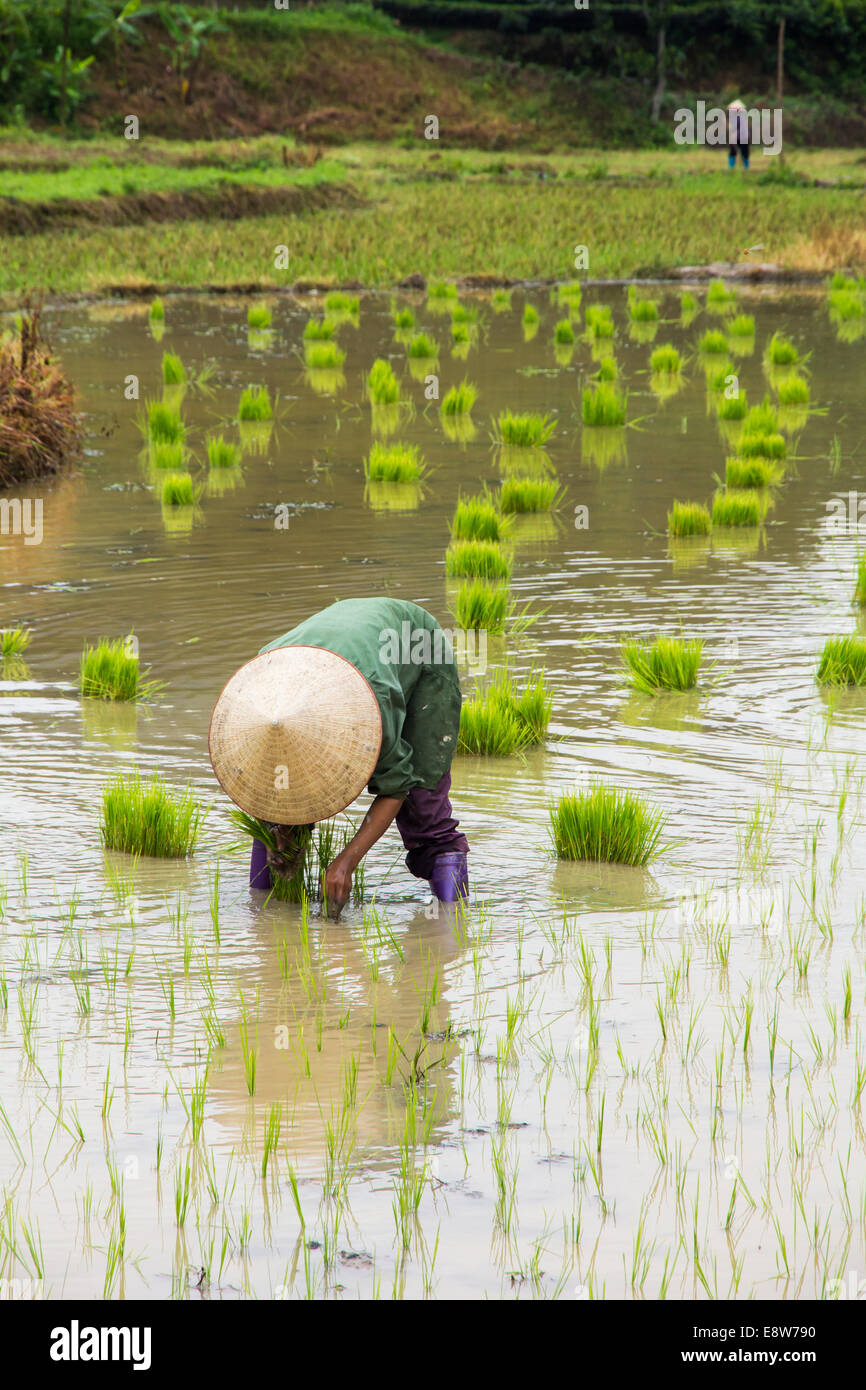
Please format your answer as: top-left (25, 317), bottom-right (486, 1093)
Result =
top-left (210, 598), bottom-right (468, 916)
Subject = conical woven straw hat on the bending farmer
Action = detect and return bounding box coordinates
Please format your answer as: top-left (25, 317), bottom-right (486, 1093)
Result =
top-left (207, 646), bottom-right (382, 826)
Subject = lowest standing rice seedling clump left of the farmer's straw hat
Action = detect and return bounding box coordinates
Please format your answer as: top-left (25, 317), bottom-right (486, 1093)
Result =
top-left (101, 771), bottom-right (206, 859)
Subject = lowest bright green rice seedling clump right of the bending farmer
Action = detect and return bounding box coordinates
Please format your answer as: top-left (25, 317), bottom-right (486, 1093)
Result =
top-left (549, 783), bottom-right (664, 865)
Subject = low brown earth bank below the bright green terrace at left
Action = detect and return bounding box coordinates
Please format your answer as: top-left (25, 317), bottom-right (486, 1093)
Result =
top-left (0, 183), bottom-right (363, 236)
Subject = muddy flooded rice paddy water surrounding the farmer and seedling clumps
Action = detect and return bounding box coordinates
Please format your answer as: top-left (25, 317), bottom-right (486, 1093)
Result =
top-left (0, 286), bottom-right (866, 1298)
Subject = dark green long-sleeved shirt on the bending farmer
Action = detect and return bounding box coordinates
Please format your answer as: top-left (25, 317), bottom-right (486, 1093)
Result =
top-left (261, 598), bottom-right (460, 798)
